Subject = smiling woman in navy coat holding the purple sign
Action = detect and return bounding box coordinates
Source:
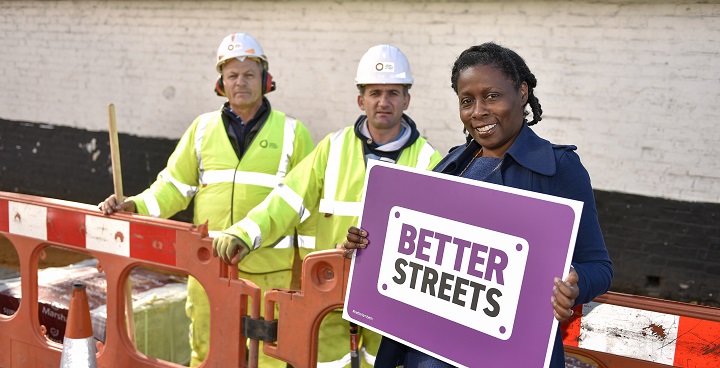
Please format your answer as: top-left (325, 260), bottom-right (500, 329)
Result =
top-left (344, 42), bottom-right (613, 368)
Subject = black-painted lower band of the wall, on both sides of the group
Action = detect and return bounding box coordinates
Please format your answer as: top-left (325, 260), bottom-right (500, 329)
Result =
top-left (0, 120), bottom-right (720, 306)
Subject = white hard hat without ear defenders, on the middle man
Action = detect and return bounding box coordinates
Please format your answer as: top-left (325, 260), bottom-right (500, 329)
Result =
top-left (355, 45), bottom-right (413, 85)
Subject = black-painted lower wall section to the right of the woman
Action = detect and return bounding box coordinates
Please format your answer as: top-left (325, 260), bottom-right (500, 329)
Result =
top-left (595, 190), bottom-right (720, 307)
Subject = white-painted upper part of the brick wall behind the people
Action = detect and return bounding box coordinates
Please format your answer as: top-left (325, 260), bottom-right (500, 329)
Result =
top-left (0, 0), bottom-right (720, 202)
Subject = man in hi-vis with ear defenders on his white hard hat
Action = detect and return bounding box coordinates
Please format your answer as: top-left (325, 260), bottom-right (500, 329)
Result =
top-left (100, 33), bottom-right (313, 367)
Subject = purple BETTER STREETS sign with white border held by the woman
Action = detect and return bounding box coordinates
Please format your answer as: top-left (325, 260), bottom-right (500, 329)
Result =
top-left (343, 161), bottom-right (582, 367)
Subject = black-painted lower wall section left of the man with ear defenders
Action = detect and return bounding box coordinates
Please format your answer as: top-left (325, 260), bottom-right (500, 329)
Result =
top-left (0, 119), bottom-right (192, 222)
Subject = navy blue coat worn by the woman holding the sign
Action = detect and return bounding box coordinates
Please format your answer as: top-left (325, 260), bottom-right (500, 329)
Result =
top-left (375, 124), bottom-right (613, 368)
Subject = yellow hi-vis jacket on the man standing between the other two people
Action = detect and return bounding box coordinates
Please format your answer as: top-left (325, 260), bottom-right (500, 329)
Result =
top-left (224, 126), bottom-right (441, 258)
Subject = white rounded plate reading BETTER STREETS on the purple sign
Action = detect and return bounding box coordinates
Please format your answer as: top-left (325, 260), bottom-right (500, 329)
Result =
top-left (378, 207), bottom-right (528, 340)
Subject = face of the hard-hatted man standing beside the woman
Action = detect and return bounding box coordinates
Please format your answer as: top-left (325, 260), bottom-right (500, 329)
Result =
top-left (358, 84), bottom-right (410, 133)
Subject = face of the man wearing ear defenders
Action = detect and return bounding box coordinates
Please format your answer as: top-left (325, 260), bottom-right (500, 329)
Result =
top-left (222, 58), bottom-right (262, 113)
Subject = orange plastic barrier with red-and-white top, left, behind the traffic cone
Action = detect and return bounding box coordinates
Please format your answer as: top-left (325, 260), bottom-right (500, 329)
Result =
top-left (0, 192), bottom-right (260, 368)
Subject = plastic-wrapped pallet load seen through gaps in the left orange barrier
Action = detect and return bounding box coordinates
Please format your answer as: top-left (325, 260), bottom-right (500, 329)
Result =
top-left (0, 259), bottom-right (190, 364)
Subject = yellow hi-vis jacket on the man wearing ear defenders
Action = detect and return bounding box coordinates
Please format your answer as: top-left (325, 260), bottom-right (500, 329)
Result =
top-left (132, 110), bottom-right (313, 273)
